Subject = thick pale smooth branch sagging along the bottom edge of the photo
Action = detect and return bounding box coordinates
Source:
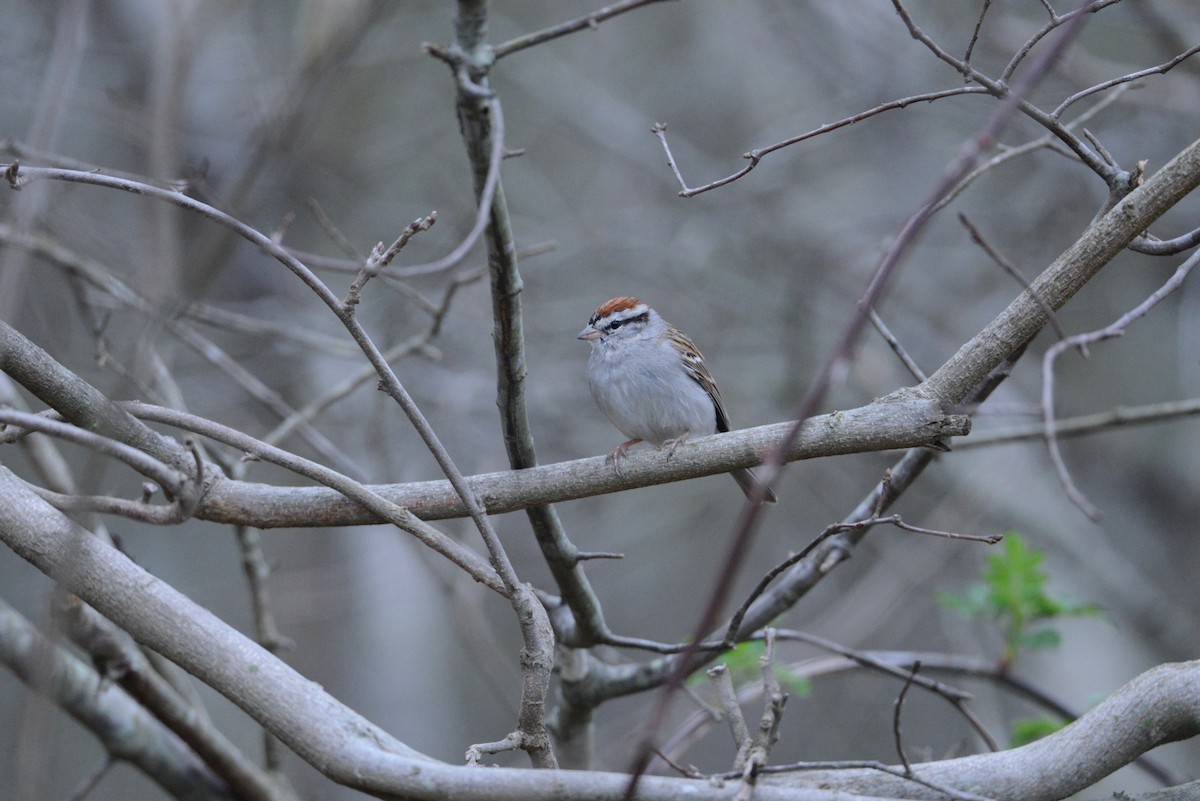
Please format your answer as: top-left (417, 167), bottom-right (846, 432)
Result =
top-left (0, 482), bottom-right (1200, 801)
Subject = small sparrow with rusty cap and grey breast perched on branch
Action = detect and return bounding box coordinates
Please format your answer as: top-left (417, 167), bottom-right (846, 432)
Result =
top-left (578, 297), bottom-right (775, 504)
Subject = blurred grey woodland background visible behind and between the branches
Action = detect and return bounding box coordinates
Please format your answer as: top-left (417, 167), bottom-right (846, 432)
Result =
top-left (0, 0), bottom-right (1200, 801)
